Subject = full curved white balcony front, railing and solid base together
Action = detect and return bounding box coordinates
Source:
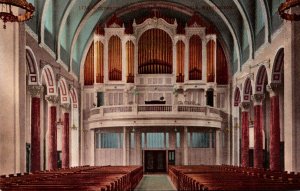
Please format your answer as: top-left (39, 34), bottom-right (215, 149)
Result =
top-left (84, 104), bottom-right (223, 129)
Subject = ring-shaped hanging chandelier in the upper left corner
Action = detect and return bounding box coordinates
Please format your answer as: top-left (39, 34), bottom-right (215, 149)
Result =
top-left (0, 0), bottom-right (35, 29)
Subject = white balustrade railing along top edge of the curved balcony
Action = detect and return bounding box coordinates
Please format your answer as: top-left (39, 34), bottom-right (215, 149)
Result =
top-left (89, 104), bottom-right (220, 118)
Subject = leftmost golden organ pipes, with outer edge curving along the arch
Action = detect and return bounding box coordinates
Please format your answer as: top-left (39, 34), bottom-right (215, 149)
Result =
top-left (84, 43), bottom-right (94, 85)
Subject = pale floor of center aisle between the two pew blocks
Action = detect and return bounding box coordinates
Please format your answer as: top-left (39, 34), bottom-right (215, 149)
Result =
top-left (135, 175), bottom-right (176, 191)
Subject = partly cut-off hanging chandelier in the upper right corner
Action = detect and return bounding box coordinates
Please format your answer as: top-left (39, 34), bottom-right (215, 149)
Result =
top-left (278, 0), bottom-right (300, 21)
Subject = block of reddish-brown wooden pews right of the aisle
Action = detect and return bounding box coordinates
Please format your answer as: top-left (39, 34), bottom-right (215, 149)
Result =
top-left (168, 165), bottom-right (300, 191)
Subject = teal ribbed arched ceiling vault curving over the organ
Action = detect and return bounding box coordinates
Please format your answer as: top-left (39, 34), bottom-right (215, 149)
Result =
top-left (27, 0), bottom-right (284, 77)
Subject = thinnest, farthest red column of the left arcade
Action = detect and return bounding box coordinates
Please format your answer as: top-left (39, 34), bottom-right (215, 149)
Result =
top-left (62, 104), bottom-right (70, 168)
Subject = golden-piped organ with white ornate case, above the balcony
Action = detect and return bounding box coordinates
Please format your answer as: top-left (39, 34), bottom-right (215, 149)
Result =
top-left (84, 13), bottom-right (228, 85)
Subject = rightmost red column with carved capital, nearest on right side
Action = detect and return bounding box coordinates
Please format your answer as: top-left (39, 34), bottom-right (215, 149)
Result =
top-left (267, 84), bottom-right (281, 171)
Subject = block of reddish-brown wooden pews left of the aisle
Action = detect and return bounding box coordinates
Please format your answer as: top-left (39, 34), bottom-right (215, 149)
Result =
top-left (0, 166), bottom-right (143, 191)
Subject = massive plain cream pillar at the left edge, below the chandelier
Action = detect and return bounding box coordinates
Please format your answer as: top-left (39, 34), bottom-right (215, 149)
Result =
top-left (0, 20), bottom-right (22, 174)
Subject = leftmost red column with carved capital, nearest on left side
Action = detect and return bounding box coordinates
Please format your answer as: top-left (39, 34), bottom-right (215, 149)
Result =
top-left (27, 85), bottom-right (44, 172)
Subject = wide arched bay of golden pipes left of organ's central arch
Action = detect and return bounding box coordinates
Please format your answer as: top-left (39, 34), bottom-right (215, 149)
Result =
top-left (108, 36), bottom-right (122, 81)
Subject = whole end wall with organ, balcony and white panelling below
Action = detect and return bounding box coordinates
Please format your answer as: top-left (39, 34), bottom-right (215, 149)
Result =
top-left (82, 13), bottom-right (229, 168)
